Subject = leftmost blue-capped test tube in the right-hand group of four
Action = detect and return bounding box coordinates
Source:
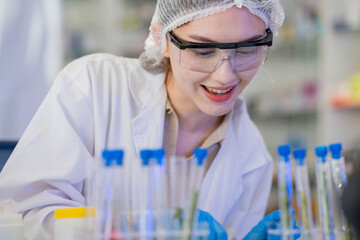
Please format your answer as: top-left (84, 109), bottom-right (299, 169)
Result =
top-left (278, 145), bottom-right (293, 239)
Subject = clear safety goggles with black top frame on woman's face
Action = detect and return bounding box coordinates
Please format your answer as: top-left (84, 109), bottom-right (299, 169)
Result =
top-left (167, 29), bottom-right (273, 73)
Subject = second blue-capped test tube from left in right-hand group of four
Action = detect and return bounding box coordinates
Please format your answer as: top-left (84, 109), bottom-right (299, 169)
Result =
top-left (293, 149), bottom-right (314, 240)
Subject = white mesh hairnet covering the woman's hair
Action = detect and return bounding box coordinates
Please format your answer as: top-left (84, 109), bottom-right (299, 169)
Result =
top-left (140, 0), bottom-right (285, 73)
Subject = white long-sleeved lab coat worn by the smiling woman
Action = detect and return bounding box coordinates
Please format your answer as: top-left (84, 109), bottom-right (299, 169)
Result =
top-left (0, 54), bottom-right (272, 240)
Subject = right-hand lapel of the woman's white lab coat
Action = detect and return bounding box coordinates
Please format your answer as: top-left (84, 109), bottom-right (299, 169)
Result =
top-left (199, 98), bottom-right (271, 223)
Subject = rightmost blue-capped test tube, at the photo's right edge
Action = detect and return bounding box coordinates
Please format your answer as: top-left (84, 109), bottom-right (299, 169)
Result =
top-left (329, 143), bottom-right (353, 240)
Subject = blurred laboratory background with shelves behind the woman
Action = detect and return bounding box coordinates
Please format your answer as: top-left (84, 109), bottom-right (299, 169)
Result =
top-left (0, 0), bottom-right (360, 227)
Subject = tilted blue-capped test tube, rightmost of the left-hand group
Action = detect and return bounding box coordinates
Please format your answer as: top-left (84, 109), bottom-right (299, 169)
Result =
top-left (184, 148), bottom-right (207, 239)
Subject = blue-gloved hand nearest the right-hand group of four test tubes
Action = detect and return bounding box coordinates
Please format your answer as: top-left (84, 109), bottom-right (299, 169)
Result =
top-left (243, 209), bottom-right (300, 240)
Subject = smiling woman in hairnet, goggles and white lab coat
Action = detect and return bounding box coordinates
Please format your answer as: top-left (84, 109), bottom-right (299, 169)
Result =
top-left (0, 0), bottom-right (284, 240)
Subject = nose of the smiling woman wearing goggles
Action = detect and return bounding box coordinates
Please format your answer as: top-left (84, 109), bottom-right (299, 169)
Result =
top-left (212, 57), bottom-right (236, 85)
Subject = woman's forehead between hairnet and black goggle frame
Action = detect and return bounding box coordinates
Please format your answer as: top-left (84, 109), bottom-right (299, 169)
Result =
top-left (173, 6), bottom-right (265, 43)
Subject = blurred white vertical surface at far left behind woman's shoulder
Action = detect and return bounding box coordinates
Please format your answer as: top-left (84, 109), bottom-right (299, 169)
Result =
top-left (0, 0), bottom-right (63, 140)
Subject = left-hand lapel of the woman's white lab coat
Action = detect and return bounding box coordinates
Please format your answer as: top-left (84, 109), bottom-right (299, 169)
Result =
top-left (130, 66), bottom-right (167, 154)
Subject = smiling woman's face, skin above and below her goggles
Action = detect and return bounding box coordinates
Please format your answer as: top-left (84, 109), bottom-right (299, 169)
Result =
top-left (163, 7), bottom-right (265, 116)
